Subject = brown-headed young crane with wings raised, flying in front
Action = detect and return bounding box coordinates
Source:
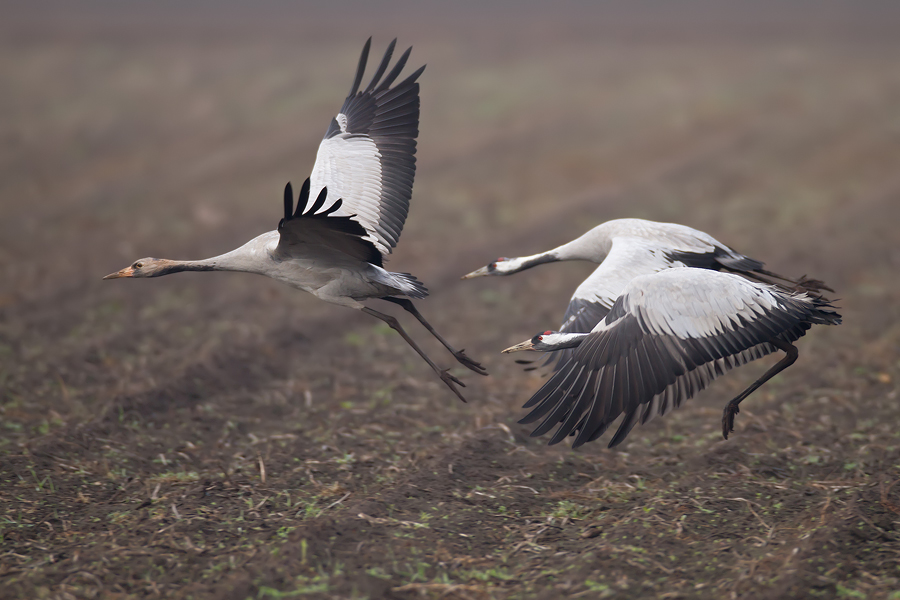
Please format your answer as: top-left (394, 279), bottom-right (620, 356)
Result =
top-left (104, 38), bottom-right (487, 402)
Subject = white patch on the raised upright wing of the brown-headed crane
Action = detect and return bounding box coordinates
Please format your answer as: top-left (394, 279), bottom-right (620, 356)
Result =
top-left (309, 135), bottom-right (391, 254)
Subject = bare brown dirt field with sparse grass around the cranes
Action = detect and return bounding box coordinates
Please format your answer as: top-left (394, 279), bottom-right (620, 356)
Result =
top-left (0, 3), bottom-right (900, 600)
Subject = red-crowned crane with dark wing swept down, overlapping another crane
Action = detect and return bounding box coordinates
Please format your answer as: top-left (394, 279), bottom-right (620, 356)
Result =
top-left (503, 267), bottom-right (841, 448)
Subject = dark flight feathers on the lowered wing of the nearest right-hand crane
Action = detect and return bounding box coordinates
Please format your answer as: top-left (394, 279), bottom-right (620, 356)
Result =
top-left (520, 288), bottom-right (840, 448)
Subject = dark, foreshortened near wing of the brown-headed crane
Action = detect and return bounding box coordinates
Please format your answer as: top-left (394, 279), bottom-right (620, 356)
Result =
top-left (275, 178), bottom-right (382, 267)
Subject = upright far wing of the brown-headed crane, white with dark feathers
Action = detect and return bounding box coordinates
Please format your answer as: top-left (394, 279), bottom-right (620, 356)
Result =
top-left (310, 38), bottom-right (425, 255)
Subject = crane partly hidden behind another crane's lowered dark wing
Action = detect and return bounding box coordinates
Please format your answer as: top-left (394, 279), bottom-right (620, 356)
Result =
top-left (463, 219), bottom-right (832, 370)
